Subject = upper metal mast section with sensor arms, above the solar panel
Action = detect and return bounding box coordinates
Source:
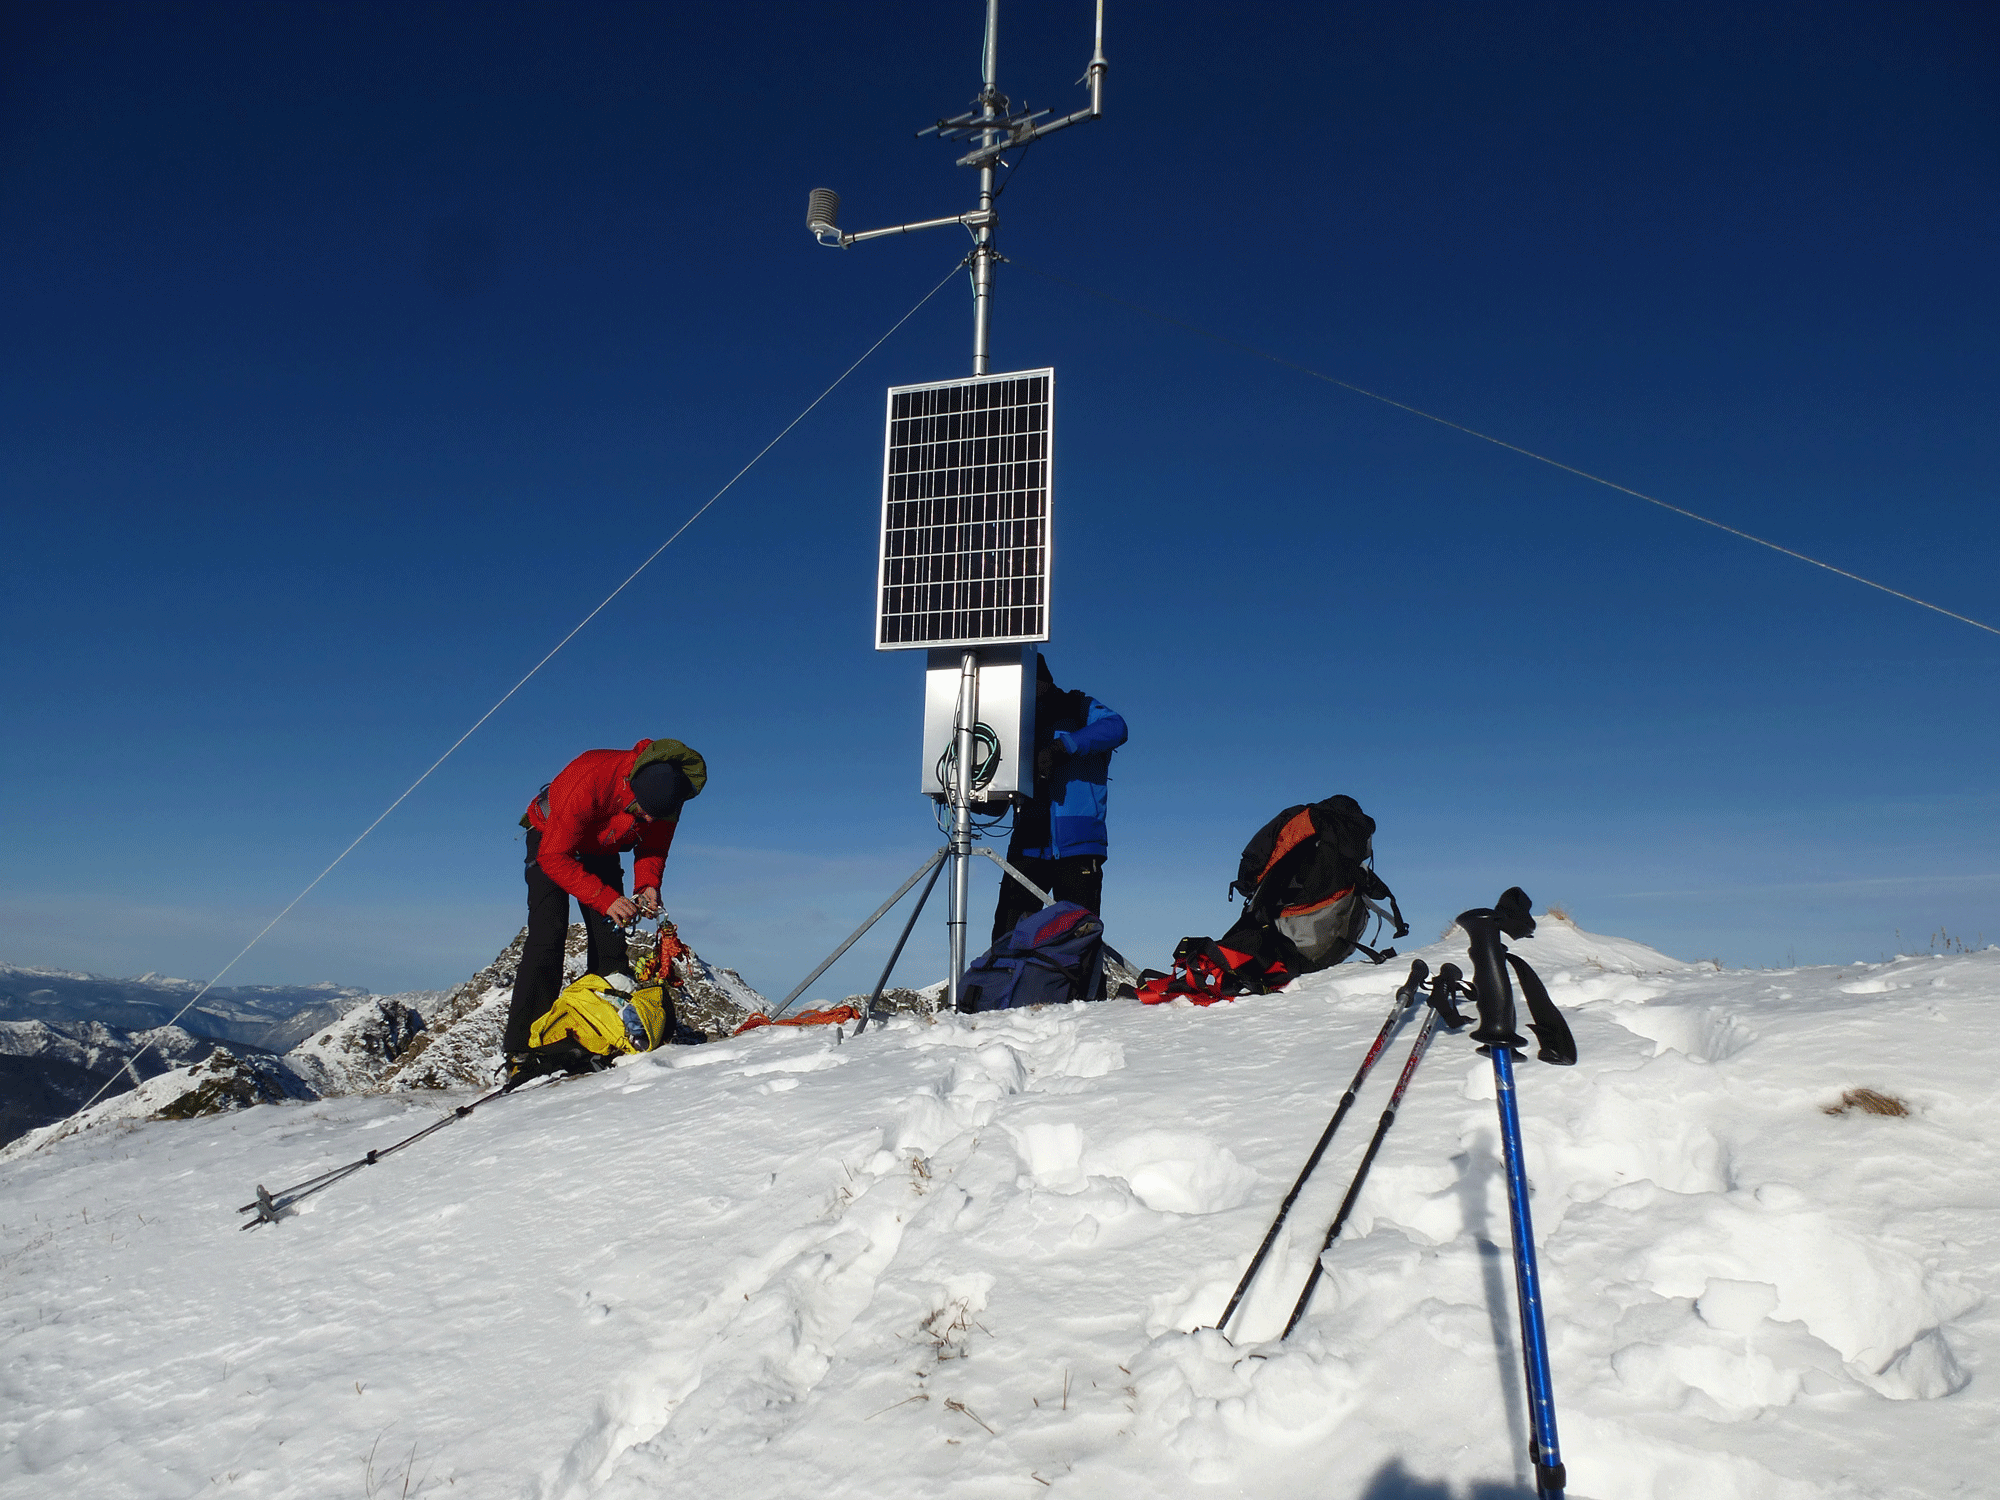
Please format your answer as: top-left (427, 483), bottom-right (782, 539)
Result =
top-left (806, 0), bottom-right (1110, 376)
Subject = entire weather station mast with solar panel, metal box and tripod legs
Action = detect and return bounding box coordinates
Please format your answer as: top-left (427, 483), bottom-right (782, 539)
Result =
top-left (778, 0), bottom-right (1110, 1028)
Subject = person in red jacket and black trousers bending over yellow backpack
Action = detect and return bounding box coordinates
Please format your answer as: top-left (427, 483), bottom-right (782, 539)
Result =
top-left (504, 740), bottom-right (708, 1066)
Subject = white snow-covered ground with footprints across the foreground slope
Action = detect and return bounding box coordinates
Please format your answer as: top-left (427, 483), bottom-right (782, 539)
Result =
top-left (0, 920), bottom-right (2000, 1500)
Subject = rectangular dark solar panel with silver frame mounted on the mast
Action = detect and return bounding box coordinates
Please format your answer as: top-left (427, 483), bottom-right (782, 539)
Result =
top-left (876, 370), bottom-right (1056, 650)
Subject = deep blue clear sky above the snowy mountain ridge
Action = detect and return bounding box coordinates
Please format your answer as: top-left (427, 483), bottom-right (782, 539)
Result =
top-left (0, 0), bottom-right (2000, 994)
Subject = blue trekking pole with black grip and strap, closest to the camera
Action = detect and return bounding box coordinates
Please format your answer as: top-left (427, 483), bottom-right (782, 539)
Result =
top-left (1458, 886), bottom-right (1576, 1500)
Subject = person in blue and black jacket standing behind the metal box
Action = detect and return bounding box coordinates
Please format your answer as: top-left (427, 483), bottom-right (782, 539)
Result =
top-left (994, 656), bottom-right (1126, 942)
